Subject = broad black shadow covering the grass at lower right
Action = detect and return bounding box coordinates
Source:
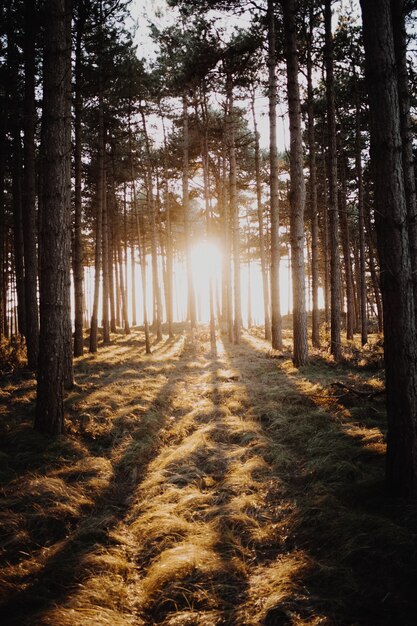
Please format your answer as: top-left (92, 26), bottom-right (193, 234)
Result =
top-left (226, 338), bottom-right (417, 626)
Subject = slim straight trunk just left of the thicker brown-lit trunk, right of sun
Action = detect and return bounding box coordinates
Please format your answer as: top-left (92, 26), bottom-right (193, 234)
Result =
top-left (268, 0), bottom-right (282, 350)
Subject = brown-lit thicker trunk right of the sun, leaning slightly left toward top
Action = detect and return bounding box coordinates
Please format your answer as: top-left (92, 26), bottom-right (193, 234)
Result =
top-left (282, 0), bottom-right (308, 367)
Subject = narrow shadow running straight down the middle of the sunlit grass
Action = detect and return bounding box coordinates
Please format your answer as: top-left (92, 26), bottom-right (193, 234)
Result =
top-left (136, 347), bottom-right (258, 626)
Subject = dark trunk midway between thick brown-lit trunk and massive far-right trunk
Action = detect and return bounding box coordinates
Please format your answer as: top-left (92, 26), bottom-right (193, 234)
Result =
top-left (324, 0), bottom-right (342, 361)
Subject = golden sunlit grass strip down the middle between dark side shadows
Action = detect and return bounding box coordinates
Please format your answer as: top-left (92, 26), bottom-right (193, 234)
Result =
top-left (135, 348), bottom-right (254, 624)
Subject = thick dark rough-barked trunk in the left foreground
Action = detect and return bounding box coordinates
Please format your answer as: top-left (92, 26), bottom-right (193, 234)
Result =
top-left (34, 0), bottom-right (71, 435)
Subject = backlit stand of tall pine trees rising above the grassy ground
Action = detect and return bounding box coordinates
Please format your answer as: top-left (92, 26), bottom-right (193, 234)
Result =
top-left (0, 0), bottom-right (417, 495)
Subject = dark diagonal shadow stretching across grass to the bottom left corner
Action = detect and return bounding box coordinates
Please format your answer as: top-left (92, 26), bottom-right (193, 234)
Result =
top-left (0, 334), bottom-right (202, 626)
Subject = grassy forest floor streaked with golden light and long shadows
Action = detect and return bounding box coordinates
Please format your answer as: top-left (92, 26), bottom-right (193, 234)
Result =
top-left (0, 330), bottom-right (417, 626)
